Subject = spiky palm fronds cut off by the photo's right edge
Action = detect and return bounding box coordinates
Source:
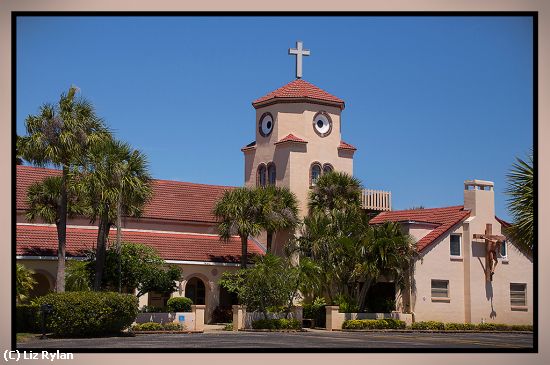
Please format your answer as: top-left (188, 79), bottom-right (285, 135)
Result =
top-left (505, 150), bottom-right (535, 251)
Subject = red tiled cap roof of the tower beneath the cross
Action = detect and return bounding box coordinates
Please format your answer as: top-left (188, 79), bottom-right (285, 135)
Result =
top-left (252, 79), bottom-right (344, 109)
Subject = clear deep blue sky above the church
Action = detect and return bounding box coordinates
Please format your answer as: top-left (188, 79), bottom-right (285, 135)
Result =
top-left (17, 17), bottom-right (533, 219)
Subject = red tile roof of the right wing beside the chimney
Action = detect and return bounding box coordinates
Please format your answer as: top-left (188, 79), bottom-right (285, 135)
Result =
top-left (370, 205), bottom-right (470, 252)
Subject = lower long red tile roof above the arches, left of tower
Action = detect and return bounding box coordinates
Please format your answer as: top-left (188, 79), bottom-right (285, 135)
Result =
top-left (16, 224), bottom-right (263, 262)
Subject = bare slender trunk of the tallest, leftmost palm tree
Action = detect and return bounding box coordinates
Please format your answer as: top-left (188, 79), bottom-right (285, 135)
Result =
top-left (55, 166), bottom-right (69, 293)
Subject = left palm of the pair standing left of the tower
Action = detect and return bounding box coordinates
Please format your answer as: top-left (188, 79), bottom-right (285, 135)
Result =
top-left (214, 187), bottom-right (265, 269)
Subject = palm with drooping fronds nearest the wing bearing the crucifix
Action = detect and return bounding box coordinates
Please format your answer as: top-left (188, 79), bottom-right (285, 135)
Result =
top-left (359, 222), bottom-right (417, 311)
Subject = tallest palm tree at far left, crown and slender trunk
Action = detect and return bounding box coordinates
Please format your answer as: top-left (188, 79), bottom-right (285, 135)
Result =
top-left (18, 87), bottom-right (109, 292)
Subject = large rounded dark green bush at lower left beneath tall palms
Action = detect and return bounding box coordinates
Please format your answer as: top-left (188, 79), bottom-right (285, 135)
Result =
top-left (36, 292), bottom-right (138, 337)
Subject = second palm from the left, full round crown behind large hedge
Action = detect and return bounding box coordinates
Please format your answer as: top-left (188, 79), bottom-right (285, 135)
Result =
top-left (76, 139), bottom-right (152, 290)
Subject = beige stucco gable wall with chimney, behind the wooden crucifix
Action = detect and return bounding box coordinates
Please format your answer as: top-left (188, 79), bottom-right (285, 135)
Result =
top-left (408, 186), bottom-right (535, 324)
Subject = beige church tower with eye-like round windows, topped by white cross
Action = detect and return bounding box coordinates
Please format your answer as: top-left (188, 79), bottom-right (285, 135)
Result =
top-left (241, 42), bottom-right (356, 217)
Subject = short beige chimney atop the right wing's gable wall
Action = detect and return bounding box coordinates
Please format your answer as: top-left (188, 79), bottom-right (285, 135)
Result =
top-left (464, 180), bottom-right (495, 218)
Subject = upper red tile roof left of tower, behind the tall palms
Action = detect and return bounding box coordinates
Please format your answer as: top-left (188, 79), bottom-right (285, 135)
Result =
top-left (16, 166), bottom-right (233, 223)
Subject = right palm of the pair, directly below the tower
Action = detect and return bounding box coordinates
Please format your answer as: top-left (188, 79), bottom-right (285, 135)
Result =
top-left (257, 186), bottom-right (300, 252)
